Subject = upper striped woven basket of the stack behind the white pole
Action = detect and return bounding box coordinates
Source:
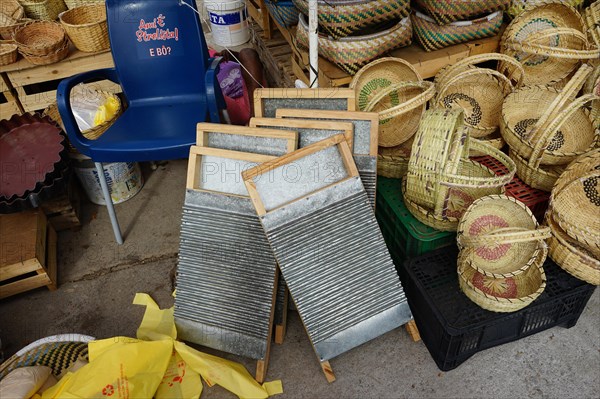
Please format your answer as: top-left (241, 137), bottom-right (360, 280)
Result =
top-left (293, 0), bottom-right (410, 39)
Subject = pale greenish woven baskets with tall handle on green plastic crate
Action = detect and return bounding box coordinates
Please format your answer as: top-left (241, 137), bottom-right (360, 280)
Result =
top-left (402, 108), bottom-right (515, 231)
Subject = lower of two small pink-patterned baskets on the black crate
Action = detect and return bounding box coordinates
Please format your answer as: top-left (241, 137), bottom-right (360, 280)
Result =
top-left (458, 247), bottom-right (547, 312)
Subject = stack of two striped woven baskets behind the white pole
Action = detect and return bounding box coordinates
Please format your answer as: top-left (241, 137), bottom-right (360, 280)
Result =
top-left (294, 0), bottom-right (412, 75)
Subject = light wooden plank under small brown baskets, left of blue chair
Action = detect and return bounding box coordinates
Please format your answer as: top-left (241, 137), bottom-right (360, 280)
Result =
top-left (5, 50), bottom-right (114, 88)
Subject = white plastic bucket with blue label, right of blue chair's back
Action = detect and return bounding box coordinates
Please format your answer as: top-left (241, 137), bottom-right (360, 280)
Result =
top-left (204, 0), bottom-right (250, 47)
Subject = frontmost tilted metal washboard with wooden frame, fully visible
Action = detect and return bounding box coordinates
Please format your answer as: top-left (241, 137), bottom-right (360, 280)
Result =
top-left (242, 135), bottom-right (411, 381)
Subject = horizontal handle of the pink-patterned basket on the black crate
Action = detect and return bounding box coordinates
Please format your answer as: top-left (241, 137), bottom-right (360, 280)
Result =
top-left (457, 226), bottom-right (552, 247)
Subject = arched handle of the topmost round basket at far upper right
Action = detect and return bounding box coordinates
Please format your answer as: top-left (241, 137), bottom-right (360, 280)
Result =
top-left (504, 28), bottom-right (600, 59)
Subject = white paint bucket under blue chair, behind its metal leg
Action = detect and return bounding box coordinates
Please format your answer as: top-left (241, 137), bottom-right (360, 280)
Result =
top-left (69, 153), bottom-right (144, 205)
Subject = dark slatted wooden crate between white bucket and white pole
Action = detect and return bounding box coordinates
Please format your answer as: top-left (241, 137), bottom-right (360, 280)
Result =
top-left (250, 24), bottom-right (296, 87)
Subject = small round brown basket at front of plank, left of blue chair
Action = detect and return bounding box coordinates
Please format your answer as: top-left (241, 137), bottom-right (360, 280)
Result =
top-left (13, 21), bottom-right (69, 65)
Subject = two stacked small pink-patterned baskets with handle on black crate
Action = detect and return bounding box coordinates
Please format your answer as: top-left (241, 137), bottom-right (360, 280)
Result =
top-left (457, 195), bottom-right (550, 312)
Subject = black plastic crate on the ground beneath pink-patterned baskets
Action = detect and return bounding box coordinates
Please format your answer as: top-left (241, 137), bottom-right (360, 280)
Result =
top-left (392, 246), bottom-right (595, 371)
